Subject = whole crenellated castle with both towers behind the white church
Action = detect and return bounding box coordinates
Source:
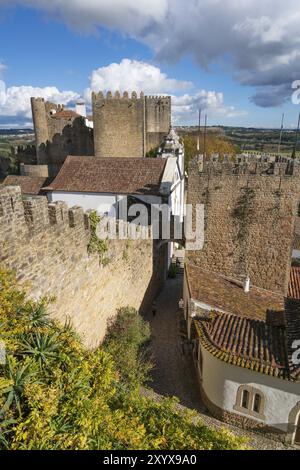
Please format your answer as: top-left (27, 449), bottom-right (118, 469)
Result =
top-left (29, 92), bottom-right (171, 176)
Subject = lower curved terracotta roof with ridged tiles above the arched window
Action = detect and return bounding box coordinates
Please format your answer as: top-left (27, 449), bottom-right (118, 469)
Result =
top-left (195, 312), bottom-right (297, 380)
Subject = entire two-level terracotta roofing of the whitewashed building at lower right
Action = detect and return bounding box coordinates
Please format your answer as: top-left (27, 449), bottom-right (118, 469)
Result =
top-left (186, 264), bottom-right (300, 381)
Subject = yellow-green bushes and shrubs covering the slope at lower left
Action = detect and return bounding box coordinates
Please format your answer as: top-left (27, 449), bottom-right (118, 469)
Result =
top-left (0, 269), bottom-right (244, 450)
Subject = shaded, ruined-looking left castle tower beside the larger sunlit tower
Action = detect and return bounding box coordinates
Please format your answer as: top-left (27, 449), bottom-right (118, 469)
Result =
top-left (31, 98), bottom-right (94, 174)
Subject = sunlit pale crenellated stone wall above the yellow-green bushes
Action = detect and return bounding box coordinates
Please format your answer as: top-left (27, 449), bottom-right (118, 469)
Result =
top-left (0, 187), bottom-right (165, 347)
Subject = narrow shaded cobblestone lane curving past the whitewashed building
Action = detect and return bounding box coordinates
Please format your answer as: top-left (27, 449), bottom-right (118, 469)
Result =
top-left (145, 274), bottom-right (296, 450)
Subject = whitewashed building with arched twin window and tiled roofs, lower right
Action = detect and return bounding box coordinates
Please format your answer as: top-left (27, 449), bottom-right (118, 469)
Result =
top-left (184, 264), bottom-right (300, 445)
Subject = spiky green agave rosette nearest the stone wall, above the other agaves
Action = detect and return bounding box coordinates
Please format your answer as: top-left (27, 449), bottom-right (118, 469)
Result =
top-left (19, 332), bottom-right (61, 368)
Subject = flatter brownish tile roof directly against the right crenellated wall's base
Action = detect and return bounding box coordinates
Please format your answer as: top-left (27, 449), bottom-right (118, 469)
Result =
top-left (186, 264), bottom-right (284, 324)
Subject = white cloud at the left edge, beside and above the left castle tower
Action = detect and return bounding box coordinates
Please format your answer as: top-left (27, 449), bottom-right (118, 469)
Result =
top-left (0, 80), bottom-right (79, 122)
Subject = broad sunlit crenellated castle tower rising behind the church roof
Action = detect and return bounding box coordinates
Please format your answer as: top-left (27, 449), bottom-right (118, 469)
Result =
top-left (92, 92), bottom-right (171, 157)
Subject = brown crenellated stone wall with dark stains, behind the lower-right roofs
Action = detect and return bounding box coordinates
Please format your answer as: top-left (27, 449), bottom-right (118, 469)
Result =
top-left (187, 160), bottom-right (300, 294)
